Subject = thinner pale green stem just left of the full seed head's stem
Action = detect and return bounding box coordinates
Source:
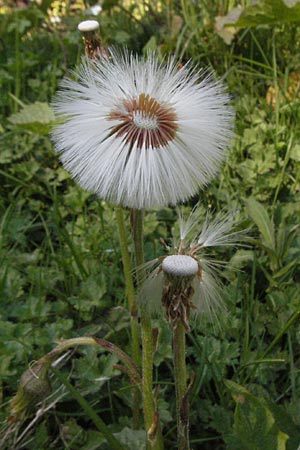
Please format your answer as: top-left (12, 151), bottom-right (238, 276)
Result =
top-left (116, 207), bottom-right (140, 429)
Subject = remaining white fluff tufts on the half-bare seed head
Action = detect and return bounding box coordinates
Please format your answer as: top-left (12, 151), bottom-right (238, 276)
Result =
top-left (142, 206), bottom-right (247, 322)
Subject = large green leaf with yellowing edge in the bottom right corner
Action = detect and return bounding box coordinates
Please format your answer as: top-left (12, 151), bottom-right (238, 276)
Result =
top-left (225, 380), bottom-right (289, 450)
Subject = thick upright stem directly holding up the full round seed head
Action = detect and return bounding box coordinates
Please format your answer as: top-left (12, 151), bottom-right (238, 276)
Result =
top-left (132, 209), bottom-right (163, 450)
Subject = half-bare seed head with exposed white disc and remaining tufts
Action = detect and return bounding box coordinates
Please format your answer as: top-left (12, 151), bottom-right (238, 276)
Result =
top-left (139, 206), bottom-right (247, 331)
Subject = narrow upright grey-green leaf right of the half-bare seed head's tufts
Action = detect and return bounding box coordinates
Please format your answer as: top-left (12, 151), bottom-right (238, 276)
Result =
top-left (246, 197), bottom-right (276, 252)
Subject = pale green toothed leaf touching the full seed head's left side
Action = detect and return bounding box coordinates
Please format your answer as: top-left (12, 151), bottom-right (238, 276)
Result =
top-left (8, 102), bottom-right (55, 134)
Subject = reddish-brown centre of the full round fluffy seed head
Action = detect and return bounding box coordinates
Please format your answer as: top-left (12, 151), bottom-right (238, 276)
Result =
top-left (108, 94), bottom-right (178, 149)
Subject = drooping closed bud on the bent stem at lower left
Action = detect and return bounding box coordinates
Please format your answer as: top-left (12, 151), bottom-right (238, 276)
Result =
top-left (9, 362), bottom-right (51, 422)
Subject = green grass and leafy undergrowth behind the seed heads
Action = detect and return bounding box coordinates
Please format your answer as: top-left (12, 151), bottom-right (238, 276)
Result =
top-left (0, 0), bottom-right (300, 450)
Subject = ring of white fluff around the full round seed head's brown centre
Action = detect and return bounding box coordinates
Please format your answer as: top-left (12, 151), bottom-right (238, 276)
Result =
top-left (52, 51), bottom-right (233, 208)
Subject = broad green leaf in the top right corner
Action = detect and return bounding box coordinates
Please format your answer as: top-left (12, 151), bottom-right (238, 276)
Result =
top-left (228, 0), bottom-right (300, 28)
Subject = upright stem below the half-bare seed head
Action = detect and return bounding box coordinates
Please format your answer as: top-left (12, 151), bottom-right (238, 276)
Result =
top-left (173, 320), bottom-right (190, 450)
